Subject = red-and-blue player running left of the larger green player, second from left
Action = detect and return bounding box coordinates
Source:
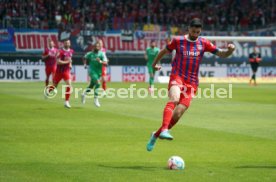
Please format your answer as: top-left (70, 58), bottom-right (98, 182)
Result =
top-left (49, 40), bottom-right (74, 108)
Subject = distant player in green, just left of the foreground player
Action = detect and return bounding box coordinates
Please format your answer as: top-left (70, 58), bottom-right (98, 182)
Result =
top-left (145, 40), bottom-right (160, 93)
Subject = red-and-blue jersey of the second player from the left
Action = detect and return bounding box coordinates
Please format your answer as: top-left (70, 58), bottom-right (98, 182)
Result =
top-left (56, 49), bottom-right (74, 73)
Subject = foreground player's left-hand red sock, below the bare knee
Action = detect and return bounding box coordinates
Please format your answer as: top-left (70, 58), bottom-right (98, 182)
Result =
top-left (154, 102), bottom-right (175, 137)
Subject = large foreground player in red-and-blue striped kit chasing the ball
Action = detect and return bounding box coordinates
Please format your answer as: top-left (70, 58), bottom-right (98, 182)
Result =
top-left (147, 18), bottom-right (235, 151)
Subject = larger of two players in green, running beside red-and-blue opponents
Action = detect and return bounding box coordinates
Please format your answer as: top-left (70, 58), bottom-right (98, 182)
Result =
top-left (82, 42), bottom-right (107, 107)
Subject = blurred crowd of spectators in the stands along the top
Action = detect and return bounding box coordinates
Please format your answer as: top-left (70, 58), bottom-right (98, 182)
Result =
top-left (0, 0), bottom-right (276, 34)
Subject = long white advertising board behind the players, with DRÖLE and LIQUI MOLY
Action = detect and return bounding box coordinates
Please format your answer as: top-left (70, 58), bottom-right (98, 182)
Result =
top-left (0, 65), bottom-right (276, 82)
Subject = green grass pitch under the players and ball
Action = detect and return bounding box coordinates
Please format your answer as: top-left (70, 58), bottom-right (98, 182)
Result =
top-left (0, 82), bottom-right (276, 182)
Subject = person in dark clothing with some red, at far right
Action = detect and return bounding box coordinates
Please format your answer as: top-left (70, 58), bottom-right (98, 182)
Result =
top-left (249, 47), bottom-right (262, 86)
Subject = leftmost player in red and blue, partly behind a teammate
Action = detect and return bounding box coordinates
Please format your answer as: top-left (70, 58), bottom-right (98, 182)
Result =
top-left (42, 39), bottom-right (58, 87)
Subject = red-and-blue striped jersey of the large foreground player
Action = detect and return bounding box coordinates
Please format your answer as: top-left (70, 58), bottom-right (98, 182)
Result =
top-left (167, 35), bottom-right (218, 86)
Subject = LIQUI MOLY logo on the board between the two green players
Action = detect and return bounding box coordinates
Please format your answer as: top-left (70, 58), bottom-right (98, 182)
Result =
top-left (122, 66), bottom-right (146, 82)
